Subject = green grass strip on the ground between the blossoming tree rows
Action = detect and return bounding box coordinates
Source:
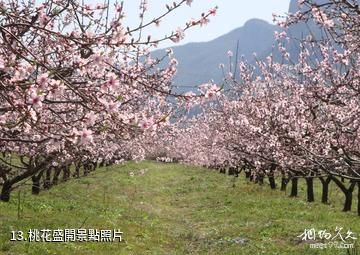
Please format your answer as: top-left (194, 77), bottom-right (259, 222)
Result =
top-left (0, 161), bottom-right (360, 255)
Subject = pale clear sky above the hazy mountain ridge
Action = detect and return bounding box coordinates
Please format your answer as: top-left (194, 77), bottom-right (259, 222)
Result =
top-left (120, 0), bottom-right (290, 48)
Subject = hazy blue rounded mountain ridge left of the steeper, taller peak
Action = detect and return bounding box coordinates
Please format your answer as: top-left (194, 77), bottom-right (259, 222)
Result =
top-left (152, 19), bottom-right (279, 92)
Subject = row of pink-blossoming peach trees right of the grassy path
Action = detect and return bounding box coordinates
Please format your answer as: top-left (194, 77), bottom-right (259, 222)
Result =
top-left (146, 0), bottom-right (360, 215)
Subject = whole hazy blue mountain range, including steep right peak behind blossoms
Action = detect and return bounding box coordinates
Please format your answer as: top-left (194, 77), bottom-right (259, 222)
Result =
top-left (152, 0), bottom-right (350, 93)
